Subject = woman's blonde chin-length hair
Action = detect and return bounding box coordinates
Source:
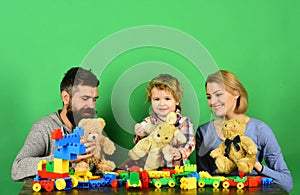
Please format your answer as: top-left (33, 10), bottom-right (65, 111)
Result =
top-left (205, 70), bottom-right (248, 114)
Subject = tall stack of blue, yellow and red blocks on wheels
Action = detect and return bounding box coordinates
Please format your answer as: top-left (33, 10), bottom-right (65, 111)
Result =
top-left (32, 127), bottom-right (88, 192)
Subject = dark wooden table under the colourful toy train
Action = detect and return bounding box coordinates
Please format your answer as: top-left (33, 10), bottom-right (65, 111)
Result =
top-left (19, 180), bottom-right (288, 195)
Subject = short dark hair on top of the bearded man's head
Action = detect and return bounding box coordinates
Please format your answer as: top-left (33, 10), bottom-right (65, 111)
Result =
top-left (60, 67), bottom-right (99, 93)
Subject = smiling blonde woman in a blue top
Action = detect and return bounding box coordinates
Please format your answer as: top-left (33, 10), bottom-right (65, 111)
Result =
top-left (196, 70), bottom-right (293, 192)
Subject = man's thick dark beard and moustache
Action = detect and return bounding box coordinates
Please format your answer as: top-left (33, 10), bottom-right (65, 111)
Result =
top-left (66, 104), bottom-right (97, 127)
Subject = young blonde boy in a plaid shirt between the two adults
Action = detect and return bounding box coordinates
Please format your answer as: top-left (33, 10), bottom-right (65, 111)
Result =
top-left (134, 74), bottom-right (195, 168)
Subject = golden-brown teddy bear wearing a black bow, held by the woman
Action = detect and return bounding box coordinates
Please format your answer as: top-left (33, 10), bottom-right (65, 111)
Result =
top-left (210, 119), bottom-right (257, 174)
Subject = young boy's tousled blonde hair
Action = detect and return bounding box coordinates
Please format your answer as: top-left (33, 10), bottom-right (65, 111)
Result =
top-left (146, 74), bottom-right (183, 103)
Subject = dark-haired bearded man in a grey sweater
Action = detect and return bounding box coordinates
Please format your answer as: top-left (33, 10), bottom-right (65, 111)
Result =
top-left (11, 67), bottom-right (99, 181)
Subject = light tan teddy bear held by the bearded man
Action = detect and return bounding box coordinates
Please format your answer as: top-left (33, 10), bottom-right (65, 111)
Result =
top-left (78, 118), bottom-right (116, 173)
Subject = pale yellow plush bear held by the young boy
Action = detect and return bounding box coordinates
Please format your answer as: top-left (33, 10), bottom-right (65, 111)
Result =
top-left (128, 112), bottom-right (186, 171)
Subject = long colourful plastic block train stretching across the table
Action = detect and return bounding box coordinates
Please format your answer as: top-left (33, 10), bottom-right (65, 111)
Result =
top-left (32, 127), bottom-right (273, 192)
